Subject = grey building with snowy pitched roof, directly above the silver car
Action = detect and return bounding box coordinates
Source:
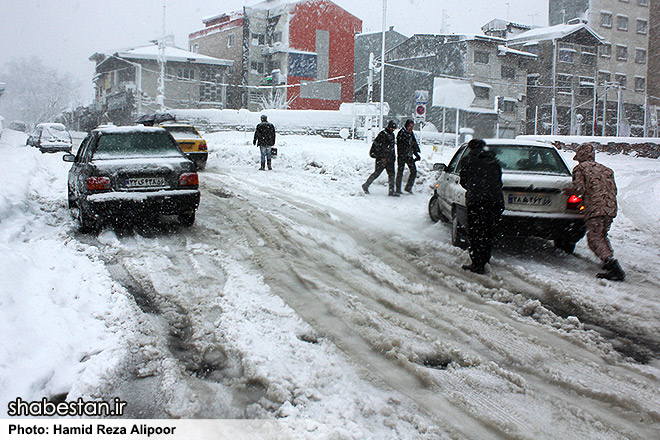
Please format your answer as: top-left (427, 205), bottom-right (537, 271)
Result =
top-left (507, 21), bottom-right (602, 135)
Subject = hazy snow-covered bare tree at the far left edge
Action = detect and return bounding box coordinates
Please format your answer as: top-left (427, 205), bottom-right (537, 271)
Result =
top-left (0, 57), bottom-right (81, 126)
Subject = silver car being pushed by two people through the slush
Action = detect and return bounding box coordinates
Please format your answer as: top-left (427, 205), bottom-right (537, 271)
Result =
top-left (428, 139), bottom-right (586, 253)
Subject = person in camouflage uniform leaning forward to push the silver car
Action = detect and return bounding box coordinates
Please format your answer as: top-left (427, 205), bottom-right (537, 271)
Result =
top-left (564, 143), bottom-right (626, 281)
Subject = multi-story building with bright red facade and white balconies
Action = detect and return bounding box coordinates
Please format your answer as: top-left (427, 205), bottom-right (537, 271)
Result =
top-left (189, 0), bottom-right (362, 110)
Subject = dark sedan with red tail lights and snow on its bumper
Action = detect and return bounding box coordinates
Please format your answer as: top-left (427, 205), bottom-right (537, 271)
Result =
top-left (63, 127), bottom-right (200, 231)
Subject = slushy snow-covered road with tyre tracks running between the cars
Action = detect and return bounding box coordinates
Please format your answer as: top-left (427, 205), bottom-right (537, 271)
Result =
top-left (0, 129), bottom-right (660, 439)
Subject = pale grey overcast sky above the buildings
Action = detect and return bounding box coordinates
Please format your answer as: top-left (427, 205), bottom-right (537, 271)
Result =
top-left (0, 0), bottom-right (548, 103)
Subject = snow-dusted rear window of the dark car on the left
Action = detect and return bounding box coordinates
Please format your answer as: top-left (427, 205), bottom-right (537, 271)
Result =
top-left (94, 132), bottom-right (181, 159)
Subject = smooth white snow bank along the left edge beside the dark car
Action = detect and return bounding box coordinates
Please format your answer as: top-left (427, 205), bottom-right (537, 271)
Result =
top-left (0, 130), bottom-right (133, 410)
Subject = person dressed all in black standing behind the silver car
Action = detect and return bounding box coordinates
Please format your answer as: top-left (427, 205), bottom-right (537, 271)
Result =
top-left (460, 139), bottom-right (504, 274)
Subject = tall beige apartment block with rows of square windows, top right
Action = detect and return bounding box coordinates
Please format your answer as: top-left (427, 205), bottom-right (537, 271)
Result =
top-left (549, 0), bottom-right (659, 134)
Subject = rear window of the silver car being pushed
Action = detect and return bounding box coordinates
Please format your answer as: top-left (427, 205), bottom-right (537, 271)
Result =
top-left (488, 145), bottom-right (571, 175)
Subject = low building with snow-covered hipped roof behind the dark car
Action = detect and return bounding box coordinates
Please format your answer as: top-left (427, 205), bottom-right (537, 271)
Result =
top-left (89, 44), bottom-right (233, 124)
